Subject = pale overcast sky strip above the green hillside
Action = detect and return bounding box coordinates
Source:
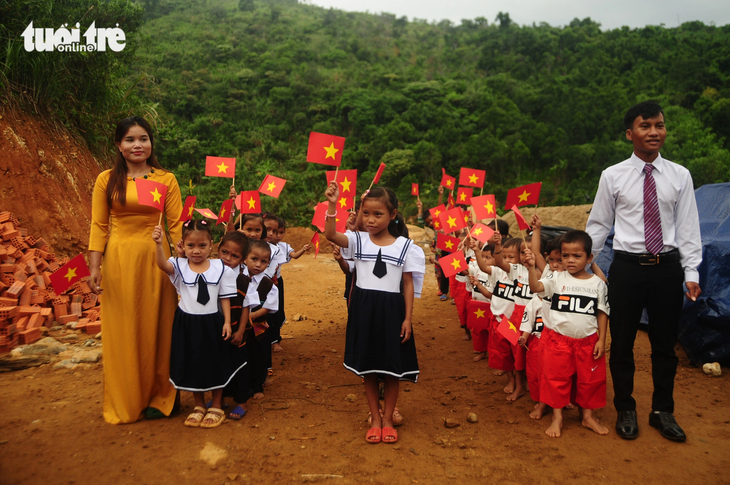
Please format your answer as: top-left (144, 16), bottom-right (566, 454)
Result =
top-left (300, 0), bottom-right (730, 30)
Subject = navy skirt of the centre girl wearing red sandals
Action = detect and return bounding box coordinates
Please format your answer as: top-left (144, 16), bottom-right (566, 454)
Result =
top-left (344, 285), bottom-right (419, 382)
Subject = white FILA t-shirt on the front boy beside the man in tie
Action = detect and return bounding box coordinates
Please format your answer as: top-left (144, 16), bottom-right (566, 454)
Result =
top-left (539, 271), bottom-right (610, 338)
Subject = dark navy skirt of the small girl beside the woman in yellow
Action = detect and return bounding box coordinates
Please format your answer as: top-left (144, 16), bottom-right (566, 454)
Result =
top-left (170, 307), bottom-right (246, 392)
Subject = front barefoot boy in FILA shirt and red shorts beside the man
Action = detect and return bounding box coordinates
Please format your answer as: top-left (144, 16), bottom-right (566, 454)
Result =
top-left (525, 230), bottom-right (609, 437)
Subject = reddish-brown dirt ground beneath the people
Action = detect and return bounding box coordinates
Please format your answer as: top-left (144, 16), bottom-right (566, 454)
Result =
top-left (0, 255), bottom-right (730, 484)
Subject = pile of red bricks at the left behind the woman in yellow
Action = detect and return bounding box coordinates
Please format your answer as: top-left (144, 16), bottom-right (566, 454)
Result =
top-left (0, 212), bottom-right (101, 352)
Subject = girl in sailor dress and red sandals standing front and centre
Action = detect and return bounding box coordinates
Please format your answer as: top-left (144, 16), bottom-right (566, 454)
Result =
top-left (325, 181), bottom-right (426, 443)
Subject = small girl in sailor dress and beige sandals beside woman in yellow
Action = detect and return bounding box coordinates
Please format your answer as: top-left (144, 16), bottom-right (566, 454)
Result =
top-left (152, 220), bottom-right (246, 428)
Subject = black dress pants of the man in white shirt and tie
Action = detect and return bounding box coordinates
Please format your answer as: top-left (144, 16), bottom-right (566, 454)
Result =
top-left (608, 257), bottom-right (684, 413)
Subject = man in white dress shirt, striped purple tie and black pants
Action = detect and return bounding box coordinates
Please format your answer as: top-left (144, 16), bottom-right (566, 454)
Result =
top-left (586, 101), bottom-right (702, 441)
